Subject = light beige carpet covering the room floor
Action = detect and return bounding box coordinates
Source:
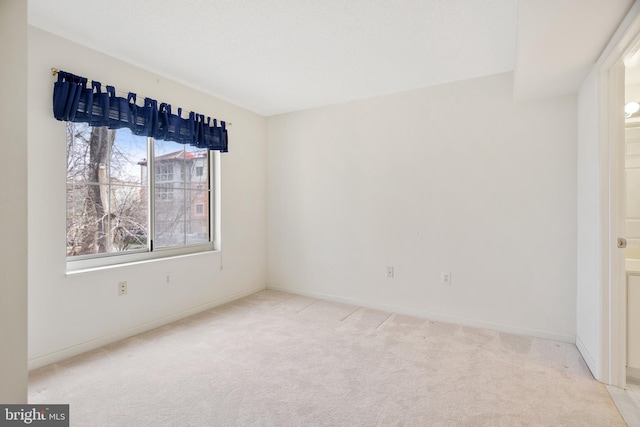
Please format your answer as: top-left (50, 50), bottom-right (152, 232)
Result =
top-left (29, 291), bottom-right (624, 426)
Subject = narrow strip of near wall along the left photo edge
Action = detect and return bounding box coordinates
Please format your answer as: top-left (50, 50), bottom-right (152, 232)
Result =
top-left (0, 0), bottom-right (27, 404)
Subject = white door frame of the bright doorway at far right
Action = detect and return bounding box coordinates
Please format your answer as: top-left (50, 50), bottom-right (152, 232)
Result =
top-left (596, 1), bottom-right (640, 388)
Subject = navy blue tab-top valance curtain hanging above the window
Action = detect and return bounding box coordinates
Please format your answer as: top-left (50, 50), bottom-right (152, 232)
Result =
top-left (53, 71), bottom-right (228, 153)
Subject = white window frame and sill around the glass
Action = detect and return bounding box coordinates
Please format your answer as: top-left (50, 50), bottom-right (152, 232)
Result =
top-left (65, 127), bottom-right (220, 273)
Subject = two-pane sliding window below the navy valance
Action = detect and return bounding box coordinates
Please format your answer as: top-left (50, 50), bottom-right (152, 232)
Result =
top-left (66, 122), bottom-right (213, 270)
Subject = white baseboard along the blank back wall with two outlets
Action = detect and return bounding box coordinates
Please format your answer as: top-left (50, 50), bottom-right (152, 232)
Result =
top-left (267, 285), bottom-right (576, 344)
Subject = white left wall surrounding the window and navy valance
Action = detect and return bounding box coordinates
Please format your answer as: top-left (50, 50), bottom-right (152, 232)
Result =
top-left (26, 28), bottom-right (267, 367)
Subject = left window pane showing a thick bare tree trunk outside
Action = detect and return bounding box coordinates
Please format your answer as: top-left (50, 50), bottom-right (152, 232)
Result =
top-left (67, 123), bottom-right (148, 256)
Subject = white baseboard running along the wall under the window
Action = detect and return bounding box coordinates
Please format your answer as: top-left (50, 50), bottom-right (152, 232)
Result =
top-left (28, 286), bottom-right (266, 370)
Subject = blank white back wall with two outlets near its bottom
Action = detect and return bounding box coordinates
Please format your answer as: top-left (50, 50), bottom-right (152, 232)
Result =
top-left (267, 73), bottom-right (577, 341)
